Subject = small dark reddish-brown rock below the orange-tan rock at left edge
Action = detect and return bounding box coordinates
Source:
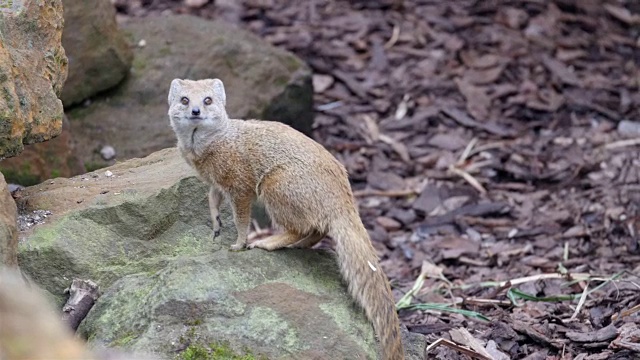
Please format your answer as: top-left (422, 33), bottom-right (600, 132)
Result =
top-left (0, 117), bottom-right (85, 186)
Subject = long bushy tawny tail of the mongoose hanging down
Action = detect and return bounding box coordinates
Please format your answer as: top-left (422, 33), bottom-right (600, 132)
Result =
top-left (328, 213), bottom-right (404, 360)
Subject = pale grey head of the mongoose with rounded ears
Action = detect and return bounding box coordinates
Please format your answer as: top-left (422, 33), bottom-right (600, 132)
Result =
top-left (169, 79), bottom-right (228, 132)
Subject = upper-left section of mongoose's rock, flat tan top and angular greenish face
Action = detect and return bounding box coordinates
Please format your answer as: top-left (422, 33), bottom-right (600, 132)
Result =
top-left (18, 148), bottom-right (218, 304)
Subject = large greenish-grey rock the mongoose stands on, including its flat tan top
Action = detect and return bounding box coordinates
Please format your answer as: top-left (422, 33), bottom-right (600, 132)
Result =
top-left (19, 148), bottom-right (424, 359)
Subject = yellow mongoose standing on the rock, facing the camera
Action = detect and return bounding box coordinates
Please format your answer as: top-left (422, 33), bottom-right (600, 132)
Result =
top-left (169, 79), bottom-right (404, 360)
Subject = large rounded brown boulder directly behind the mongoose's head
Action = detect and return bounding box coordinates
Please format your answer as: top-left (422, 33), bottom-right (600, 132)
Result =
top-left (67, 15), bottom-right (313, 169)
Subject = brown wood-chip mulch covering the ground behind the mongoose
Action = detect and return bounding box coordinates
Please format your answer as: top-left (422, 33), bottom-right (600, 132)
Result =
top-left (116, 0), bottom-right (640, 359)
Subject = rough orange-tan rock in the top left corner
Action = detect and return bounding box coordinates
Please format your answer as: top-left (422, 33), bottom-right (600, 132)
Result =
top-left (0, 0), bottom-right (67, 159)
